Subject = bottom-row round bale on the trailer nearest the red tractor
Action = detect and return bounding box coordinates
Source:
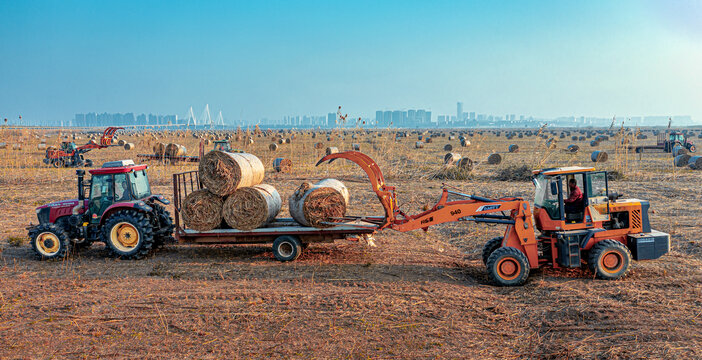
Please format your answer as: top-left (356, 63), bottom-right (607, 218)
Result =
top-left (181, 189), bottom-right (223, 231)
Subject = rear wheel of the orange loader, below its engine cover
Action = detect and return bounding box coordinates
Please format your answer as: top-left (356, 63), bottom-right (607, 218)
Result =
top-left (587, 239), bottom-right (631, 280)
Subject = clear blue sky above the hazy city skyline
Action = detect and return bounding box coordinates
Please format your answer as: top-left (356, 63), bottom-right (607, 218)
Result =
top-left (0, 0), bottom-right (702, 121)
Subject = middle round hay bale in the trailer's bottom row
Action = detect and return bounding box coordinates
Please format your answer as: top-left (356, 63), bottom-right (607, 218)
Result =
top-left (222, 184), bottom-right (283, 230)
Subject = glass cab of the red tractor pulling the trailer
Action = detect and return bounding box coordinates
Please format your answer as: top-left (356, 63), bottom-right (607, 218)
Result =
top-left (88, 160), bottom-right (151, 223)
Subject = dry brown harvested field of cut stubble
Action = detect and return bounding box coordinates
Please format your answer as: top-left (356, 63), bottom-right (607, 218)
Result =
top-left (0, 128), bottom-right (702, 359)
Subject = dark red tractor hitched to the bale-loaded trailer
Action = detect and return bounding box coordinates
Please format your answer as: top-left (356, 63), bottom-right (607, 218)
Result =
top-left (29, 160), bottom-right (174, 260)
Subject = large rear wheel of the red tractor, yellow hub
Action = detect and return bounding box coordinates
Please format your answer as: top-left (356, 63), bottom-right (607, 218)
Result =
top-left (102, 210), bottom-right (154, 259)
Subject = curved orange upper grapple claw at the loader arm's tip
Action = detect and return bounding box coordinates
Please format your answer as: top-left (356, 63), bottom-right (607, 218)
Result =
top-left (316, 151), bottom-right (397, 227)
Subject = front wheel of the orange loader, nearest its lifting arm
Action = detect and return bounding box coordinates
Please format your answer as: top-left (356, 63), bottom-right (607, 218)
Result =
top-left (487, 246), bottom-right (529, 286)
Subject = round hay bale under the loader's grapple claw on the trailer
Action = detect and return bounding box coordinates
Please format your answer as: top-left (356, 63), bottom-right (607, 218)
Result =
top-left (288, 179), bottom-right (349, 228)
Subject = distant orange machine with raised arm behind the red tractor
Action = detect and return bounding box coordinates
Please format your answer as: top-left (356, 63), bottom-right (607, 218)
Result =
top-left (44, 127), bottom-right (122, 168)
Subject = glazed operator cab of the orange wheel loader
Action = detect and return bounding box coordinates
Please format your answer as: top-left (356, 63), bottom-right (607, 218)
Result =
top-left (533, 167), bottom-right (608, 231)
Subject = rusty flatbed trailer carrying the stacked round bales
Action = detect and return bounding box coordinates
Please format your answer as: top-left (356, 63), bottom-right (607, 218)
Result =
top-left (173, 171), bottom-right (378, 261)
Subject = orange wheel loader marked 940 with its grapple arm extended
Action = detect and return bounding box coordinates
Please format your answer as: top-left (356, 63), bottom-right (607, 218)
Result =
top-left (317, 151), bottom-right (670, 286)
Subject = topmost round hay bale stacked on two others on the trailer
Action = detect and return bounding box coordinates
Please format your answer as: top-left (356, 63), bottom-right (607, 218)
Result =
top-left (199, 150), bottom-right (265, 196)
